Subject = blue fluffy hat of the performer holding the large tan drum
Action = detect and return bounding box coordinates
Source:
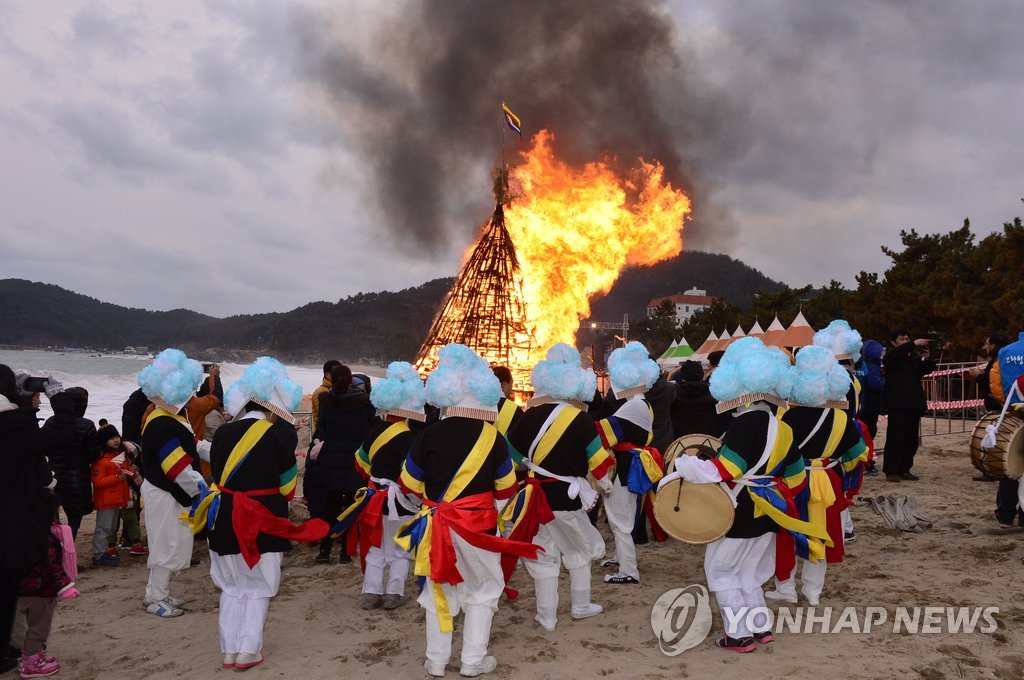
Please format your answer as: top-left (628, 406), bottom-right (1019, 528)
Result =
top-left (709, 338), bottom-right (791, 413)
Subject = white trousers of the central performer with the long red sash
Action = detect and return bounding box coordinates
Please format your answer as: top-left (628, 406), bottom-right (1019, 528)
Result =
top-left (417, 529), bottom-right (505, 667)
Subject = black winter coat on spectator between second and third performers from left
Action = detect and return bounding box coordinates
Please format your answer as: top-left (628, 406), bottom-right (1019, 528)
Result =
top-left (306, 387), bottom-right (377, 494)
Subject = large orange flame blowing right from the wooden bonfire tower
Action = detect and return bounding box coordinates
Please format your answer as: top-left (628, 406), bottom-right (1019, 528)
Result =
top-left (505, 130), bottom-right (690, 351)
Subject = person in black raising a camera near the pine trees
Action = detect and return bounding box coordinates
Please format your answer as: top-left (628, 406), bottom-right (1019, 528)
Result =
top-left (882, 330), bottom-right (935, 482)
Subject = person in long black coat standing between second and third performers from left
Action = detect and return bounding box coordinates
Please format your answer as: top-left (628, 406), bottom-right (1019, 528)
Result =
top-left (304, 365), bottom-right (377, 564)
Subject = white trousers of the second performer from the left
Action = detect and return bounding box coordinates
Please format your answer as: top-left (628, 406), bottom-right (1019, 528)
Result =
top-left (210, 550), bottom-right (284, 654)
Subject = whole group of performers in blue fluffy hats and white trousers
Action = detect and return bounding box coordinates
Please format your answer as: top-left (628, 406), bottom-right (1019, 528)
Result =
top-left (128, 322), bottom-right (869, 677)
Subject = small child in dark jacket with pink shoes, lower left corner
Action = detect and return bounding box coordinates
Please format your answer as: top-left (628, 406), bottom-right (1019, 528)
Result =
top-left (17, 494), bottom-right (79, 678)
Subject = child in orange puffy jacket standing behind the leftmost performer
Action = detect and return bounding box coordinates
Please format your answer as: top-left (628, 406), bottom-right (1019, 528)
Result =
top-left (92, 423), bottom-right (131, 566)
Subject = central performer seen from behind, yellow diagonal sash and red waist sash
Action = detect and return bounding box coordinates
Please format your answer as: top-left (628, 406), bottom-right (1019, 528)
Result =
top-left (397, 343), bottom-right (539, 677)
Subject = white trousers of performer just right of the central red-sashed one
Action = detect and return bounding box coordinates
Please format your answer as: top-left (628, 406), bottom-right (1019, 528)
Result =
top-left (522, 509), bottom-right (604, 628)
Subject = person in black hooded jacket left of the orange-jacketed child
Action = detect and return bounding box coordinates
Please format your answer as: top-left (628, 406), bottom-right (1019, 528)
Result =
top-left (43, 387), bottom-right (102, 537)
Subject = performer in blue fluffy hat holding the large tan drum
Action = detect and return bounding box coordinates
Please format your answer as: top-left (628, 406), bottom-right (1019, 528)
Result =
top-left (666, 338), bottom-right (825, 652)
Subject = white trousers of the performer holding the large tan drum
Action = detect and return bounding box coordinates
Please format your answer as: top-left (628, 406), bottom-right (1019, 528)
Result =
top-left (705, 534), bottom-right (775, 638)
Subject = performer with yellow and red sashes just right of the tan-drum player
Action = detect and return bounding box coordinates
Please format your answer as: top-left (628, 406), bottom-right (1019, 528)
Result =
top-left (765, 346), bottom-right (867, 606)
